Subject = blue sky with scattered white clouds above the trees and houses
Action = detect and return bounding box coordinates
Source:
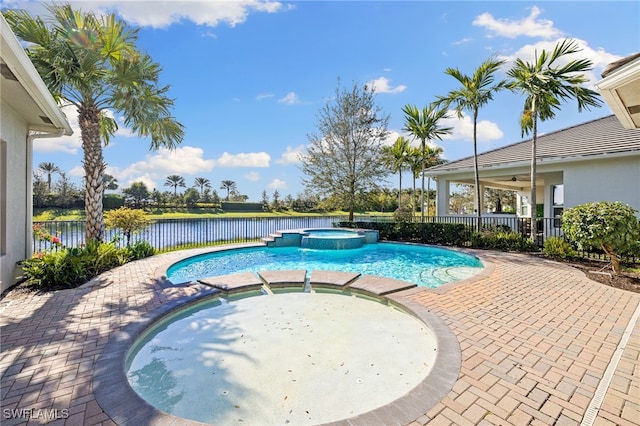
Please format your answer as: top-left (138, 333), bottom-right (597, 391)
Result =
top-left (0, 0), bottom-right (640, 201)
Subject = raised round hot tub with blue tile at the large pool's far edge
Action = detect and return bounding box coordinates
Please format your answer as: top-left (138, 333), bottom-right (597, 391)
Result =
top-left (264, 228), bottom-right (378, 250)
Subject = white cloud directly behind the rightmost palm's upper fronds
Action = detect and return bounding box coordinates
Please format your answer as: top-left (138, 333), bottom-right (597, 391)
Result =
top-left (501, 38), bottom-right (622, 88)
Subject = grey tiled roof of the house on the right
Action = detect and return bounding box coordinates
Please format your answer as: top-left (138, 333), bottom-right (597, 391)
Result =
top-left (426, 115), bottom-right (640, 176)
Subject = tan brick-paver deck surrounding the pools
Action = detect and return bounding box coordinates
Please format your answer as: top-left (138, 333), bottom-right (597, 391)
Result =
top-left (0, 249), bottom-right (640, 426)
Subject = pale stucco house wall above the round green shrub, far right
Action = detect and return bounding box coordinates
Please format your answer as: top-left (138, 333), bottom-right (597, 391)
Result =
top-left (564, 155), bottom-right (640, 218)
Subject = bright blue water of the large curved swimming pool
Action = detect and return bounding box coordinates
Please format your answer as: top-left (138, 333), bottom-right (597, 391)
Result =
top-left (167, 243), bottom-right (482, 288)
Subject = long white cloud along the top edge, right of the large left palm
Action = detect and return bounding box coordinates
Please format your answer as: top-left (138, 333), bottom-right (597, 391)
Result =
top-left (85, 0), bottom-right (285, 28)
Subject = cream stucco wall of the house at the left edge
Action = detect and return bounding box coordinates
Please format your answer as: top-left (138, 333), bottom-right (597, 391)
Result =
top-left (0, 99), bottom-right (31, 291)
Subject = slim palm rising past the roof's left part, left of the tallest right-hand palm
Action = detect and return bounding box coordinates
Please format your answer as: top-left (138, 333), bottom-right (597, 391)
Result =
top-left (436, 57), bottom-right (507, 230)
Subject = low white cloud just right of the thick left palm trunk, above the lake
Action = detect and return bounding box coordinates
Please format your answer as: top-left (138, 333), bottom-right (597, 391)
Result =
top-left (106, 146), bottom-right (215, 188)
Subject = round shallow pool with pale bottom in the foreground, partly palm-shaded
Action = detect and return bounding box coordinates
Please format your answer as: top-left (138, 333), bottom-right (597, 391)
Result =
top-left (126, 293), bottom-right (444, 425)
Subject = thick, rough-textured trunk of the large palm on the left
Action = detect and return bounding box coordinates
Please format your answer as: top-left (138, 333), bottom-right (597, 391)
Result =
top-left (78, 102), bottom-right (104, 241)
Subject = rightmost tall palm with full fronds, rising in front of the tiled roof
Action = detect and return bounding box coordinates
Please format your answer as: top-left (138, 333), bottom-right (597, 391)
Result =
top-left (507, 40), bottom-right (601, 241)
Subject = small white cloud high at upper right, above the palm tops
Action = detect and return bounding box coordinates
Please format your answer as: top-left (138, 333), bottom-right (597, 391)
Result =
top-left (472, 6), bottom-right (562, 39)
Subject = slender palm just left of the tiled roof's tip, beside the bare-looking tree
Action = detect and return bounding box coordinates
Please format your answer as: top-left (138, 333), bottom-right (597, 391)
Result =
top-left (402, 104), bottom-right (452, 222)
